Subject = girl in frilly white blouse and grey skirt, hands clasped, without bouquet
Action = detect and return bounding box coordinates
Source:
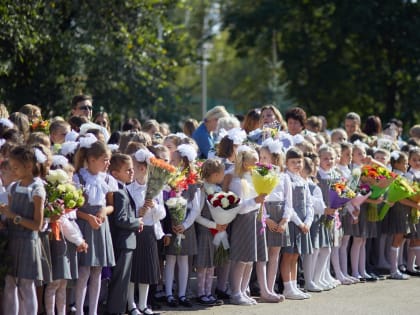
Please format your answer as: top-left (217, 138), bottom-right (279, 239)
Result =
top-left (73, 138), bottom-right (118, 315)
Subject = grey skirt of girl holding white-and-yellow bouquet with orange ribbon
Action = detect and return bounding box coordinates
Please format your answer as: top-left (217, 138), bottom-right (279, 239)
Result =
top-left (50, 239), bottom-right (79, 280)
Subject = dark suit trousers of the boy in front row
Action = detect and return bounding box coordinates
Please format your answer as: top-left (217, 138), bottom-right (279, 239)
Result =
top-left (106, 248), bottom-right (133, 313)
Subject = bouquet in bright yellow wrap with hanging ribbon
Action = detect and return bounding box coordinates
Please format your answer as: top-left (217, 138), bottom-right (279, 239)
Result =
top-left (251, 163), bottom-right (279, 225)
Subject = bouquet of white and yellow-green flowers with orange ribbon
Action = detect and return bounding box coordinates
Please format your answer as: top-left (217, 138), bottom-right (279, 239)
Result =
top-left (44, 169), bottom-right (85, 240)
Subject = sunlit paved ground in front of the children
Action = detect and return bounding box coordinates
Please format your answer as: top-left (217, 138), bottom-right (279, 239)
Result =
top-left (159, 278), bottom-right (420, 315)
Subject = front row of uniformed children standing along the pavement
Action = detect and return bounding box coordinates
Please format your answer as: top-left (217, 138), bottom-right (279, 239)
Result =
top-left (1, 130), bottom-right (420, 314)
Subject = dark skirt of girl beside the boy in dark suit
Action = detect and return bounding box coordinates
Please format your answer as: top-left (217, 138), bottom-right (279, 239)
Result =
top-left (131, 225), bottom-right (160, 284)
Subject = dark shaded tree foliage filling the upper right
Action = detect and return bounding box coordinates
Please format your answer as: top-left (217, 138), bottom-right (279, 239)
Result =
top-left (223, 0), bottom-right (420, 130)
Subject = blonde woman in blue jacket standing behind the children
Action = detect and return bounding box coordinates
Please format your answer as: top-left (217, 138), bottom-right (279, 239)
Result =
top-left (192, 105), bottom-right (229, 159)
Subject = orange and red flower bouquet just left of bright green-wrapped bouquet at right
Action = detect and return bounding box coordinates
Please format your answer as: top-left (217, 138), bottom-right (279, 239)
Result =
top-left (361, 164), bottom-right (397, 222)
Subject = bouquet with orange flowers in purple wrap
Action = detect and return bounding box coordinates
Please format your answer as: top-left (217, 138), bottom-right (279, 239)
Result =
top-left (324, 181), bottom-right (356, 229)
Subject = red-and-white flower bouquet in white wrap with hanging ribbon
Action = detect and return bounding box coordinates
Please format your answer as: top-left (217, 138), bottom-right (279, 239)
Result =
top-left (206, 191), bottom-right (241, 266)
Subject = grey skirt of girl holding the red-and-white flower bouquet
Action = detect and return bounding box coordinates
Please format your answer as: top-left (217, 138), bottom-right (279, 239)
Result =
top-left (194, 223), bottom-right (216, 268)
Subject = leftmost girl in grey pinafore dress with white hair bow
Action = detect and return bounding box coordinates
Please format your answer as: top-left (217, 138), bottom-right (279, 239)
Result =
top-left (0, 146), bottom-right (46, 315)
